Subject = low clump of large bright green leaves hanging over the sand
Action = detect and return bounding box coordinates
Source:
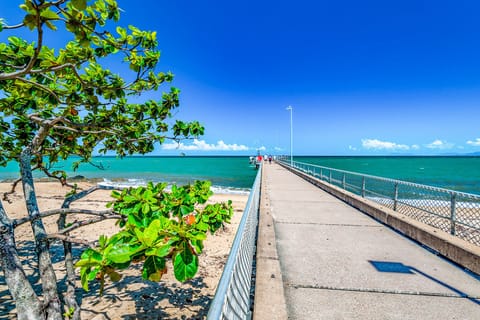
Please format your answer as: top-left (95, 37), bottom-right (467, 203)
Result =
top-left (76, 181), bottom-right (232, 290)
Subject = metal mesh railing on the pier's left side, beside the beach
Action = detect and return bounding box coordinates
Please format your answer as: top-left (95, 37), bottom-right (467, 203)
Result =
top-left (207, 166), bottom-right (262, 320)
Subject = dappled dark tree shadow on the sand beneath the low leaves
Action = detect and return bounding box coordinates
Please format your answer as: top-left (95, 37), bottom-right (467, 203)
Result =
top-left (0, 241), bottom-right (213, 320)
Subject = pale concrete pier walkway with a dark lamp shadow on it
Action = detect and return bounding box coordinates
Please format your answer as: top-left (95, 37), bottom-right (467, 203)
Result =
top-left (254, 163), bottom-right (480, 320)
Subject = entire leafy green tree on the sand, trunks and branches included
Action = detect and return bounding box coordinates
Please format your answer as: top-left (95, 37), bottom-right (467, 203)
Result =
top-left (0, 0), bottom-right (232, 319)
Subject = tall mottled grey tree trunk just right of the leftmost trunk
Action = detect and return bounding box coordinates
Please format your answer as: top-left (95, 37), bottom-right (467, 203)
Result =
top-left (20, 147), bottom-right (62, 320)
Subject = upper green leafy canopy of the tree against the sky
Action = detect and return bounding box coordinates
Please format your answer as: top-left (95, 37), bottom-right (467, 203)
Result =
top-left (0, 0), bottom-right (204, 178)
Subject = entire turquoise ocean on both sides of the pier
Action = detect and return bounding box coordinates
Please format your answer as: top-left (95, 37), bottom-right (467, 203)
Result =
top-left (0, 156), bottom-right (480, 195)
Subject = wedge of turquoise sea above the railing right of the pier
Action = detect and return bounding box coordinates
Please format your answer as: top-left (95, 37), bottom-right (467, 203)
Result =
top-left (294, 156), bottom-right (480, 195)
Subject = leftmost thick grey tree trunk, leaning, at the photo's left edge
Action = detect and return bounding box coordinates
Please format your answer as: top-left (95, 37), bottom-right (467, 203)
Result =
top-left (0, 201), bottom-right (44, 320)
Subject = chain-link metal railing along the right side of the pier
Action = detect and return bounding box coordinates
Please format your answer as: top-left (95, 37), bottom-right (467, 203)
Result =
top-left (278, 158), bottom-right (480, 246)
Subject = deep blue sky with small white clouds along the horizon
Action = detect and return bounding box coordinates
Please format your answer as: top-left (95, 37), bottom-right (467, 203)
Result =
top-left (0, 0), bottom-right (480, 155)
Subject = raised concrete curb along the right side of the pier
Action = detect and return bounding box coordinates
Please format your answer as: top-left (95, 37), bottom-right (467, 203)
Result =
top-left (279, 163), bottom-right (480, 274)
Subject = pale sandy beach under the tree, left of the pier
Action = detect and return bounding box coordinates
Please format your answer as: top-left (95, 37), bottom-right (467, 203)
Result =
top-left (0, 182), bottom-right (248, 319)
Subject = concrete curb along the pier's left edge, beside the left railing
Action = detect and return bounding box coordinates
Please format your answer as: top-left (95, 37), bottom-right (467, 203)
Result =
top-left (253, 166), bottom-right (287, 320)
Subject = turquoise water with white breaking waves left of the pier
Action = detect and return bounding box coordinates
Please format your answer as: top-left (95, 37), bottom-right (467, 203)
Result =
top-left (0, 156), bottom-right (257, 193)
